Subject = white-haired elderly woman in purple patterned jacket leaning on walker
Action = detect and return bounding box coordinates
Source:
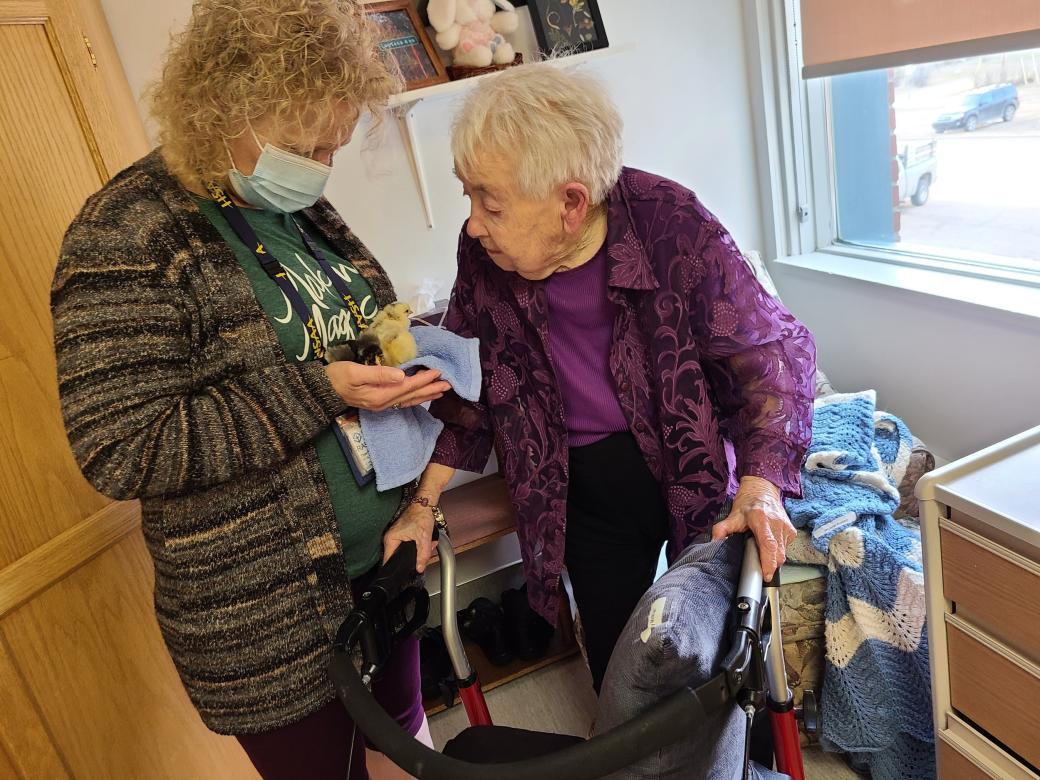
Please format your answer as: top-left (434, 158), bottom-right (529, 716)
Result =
top-left (401, 64), bottom-right (815, 690)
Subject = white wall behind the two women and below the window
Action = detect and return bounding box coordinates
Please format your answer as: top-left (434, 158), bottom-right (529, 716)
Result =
top-left (95, 0), bottom-right (1040, 470)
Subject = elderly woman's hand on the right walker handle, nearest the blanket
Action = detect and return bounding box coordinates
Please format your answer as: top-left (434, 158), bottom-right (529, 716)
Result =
top-left (711, 476), bottom-right (797, 581)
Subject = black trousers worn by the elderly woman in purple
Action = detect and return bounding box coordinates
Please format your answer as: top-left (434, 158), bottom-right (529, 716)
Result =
top-left (565, 433), bottom-right (669, 693)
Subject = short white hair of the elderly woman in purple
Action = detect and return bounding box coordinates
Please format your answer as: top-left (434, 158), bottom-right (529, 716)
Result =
top-left (451, 62), bottom-right (624, 204)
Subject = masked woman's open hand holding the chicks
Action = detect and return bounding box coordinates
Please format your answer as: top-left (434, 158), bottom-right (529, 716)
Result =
top-left (324, 360), bottom-right (451, 412)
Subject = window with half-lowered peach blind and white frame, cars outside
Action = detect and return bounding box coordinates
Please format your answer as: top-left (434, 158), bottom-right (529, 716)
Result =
top-left (748, 0), bottom-right (1040, 291)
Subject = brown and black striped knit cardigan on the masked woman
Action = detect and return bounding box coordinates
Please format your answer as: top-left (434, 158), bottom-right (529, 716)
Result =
top-left (51, 151), bottom-right (394, 734)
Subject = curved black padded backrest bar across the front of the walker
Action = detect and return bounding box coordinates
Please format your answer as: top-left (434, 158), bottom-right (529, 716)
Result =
top-left (330, 651), bottom-right (730, 780)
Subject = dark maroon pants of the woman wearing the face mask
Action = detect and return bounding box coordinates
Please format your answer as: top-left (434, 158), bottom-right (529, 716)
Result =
top-left (237, 575), bottom-right (423, 780)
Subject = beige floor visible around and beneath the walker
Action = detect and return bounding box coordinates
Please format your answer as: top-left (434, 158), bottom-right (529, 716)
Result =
top-left (430, 657), bottom-right (857, 780)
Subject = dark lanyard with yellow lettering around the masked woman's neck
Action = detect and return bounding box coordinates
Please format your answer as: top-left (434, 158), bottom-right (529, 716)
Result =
top-left (206, 183), bottom-right (368, 359)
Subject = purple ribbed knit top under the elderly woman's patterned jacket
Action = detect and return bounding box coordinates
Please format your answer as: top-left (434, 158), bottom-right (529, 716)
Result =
top-left (546, 242), bottom-right (628, 447)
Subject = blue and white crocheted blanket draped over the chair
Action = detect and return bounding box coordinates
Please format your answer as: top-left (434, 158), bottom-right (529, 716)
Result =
top-left (786, 390), bottom-right (935, 780)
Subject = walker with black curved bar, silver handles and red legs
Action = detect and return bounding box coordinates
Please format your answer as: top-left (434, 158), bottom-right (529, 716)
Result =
top-left (331, 525), bottom-right (814, 780)
